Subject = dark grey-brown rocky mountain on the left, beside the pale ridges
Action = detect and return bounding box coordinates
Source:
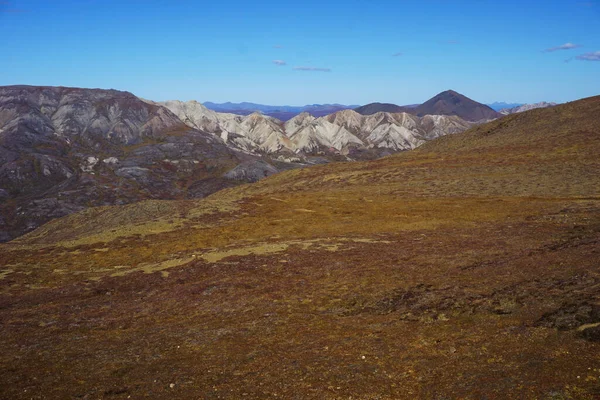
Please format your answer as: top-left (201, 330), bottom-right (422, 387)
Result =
top-left (0, 86), bottom-right (277, 241)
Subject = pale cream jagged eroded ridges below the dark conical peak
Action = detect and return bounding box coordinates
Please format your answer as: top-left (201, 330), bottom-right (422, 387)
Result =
top-left (160, 101), bottom-right (471, 159)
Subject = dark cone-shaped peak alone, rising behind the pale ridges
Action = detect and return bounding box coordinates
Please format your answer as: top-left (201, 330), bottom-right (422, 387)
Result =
top-left (407, 90), bottom-right (502, 121)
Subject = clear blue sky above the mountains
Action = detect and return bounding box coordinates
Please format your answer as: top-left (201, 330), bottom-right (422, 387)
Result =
top-left (0, 0), bottom-right (600, 105)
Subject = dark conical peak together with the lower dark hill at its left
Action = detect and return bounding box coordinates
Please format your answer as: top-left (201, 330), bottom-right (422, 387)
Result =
top-left (354, 90), bottom-right (502, 122)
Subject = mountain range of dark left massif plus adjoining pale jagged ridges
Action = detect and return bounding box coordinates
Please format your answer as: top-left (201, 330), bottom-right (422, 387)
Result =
top-left (0, 86), bottom-right (486, 241)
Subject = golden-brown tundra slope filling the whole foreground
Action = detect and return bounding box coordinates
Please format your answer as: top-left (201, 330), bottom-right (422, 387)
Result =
top-left (0, 97), bottom-right (600, 399)
